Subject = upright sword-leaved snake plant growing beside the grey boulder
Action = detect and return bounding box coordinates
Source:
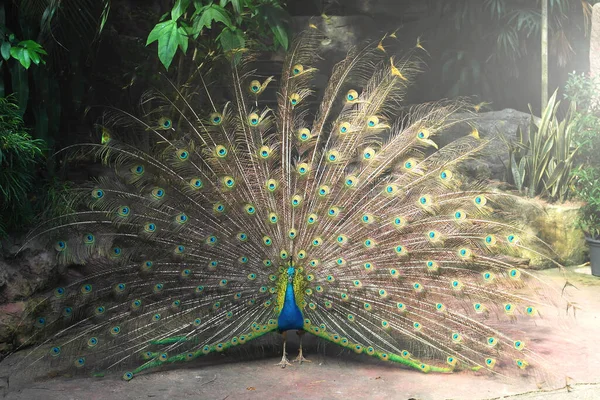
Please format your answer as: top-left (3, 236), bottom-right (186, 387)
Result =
top-left (504, 91), bottom-right (579, 202)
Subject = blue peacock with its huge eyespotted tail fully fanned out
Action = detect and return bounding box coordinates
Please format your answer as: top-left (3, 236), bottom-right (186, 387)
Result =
top-left (11, 25), bottom-right (560, 386)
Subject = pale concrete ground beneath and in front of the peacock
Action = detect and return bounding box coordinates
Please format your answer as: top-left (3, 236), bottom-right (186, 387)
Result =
top-left (0, 267), bottom-right (600, 400)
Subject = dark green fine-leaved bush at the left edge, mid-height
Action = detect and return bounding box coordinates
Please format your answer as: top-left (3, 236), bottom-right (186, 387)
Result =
top-left (0, 98), bottom-right (45, 238)
